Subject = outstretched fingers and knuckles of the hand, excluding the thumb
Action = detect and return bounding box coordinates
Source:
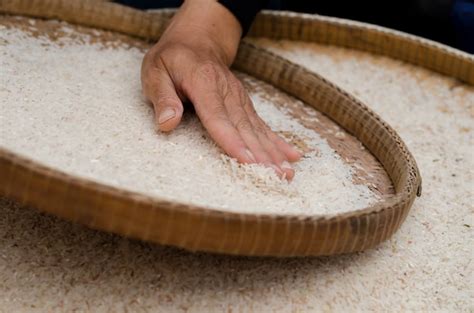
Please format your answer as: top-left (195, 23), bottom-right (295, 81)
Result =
top-left (183, 63), bottom-right (300, 179)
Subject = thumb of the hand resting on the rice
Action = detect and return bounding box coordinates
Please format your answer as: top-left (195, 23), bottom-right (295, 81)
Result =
top-left (142, 54), bottom-right (183, 132)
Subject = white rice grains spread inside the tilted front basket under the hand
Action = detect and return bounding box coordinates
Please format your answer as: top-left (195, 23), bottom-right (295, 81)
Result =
top-left (0, 20), bottom-right (378, 215)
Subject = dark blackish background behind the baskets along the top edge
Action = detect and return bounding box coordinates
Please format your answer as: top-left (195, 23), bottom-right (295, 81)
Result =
top-left (116, 0), bottom-right (474, 53)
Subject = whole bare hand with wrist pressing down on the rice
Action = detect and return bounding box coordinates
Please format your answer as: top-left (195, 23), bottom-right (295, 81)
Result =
top-left (141, 0), bottom-right (301, 179)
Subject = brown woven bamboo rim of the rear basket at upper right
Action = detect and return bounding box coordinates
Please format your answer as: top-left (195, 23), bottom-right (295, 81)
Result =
top-left (249, 12), bottom-right (474, 85)
